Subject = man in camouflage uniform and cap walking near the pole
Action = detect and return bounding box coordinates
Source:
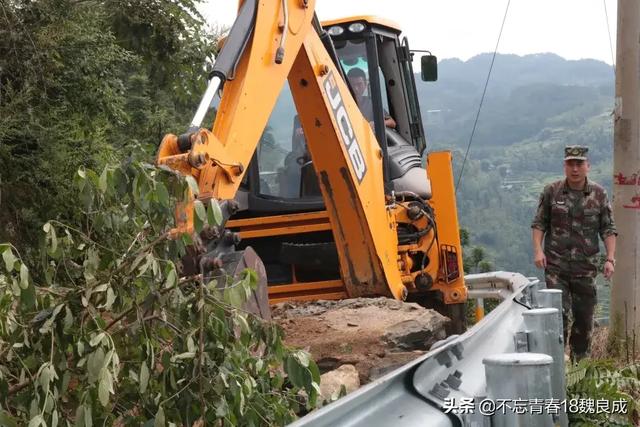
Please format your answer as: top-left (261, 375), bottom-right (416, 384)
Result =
top-left (531, 145), bottom-right (617, 360)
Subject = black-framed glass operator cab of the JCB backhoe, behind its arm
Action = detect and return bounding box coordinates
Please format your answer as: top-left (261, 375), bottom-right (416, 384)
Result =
top-left (239, 16), bottom-right (435, 217)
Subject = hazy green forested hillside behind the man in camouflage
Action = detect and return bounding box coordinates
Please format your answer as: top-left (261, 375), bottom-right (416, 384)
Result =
top-left (418, 54), bottom-right (614, 276)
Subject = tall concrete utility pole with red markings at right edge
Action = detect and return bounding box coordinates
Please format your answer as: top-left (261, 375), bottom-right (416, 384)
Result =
top-left (610, 0), bottom-right (640, 358)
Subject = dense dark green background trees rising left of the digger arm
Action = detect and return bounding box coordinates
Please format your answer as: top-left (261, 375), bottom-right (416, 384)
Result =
top-left (0, 0), bottom-right (216, 258)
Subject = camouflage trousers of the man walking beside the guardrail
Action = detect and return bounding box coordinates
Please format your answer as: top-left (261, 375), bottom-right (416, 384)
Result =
top-left (544, 264), bottom-right (597, 360)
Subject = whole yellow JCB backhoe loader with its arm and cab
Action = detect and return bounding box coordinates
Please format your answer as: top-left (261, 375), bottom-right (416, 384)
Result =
top-left (157, 0), bottom-right (467, 330)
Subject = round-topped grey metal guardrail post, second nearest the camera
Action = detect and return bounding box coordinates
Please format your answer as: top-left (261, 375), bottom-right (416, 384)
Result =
top-left (522, 310), bottom-right (569, 427)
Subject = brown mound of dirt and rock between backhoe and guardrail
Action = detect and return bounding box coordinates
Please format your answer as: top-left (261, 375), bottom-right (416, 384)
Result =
top-left (272, 298), bottom-right (449, 384)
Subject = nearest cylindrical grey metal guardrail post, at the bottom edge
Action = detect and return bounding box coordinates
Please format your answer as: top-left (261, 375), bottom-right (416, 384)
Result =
top-left (480, 353), bottom-right (554, 427)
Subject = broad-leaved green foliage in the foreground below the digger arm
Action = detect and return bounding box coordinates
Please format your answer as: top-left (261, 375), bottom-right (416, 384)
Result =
top-left (0, 162), bottom-right (319, 426)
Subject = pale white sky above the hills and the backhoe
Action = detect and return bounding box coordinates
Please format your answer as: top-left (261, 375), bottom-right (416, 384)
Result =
top-left (200, 0), bottom-right (617, 64)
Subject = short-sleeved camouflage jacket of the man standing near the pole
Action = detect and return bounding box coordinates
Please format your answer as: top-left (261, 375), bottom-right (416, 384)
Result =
top-left (531, 179), bottom-right (618, 267)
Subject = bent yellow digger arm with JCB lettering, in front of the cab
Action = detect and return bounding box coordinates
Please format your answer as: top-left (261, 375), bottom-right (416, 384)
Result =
top-left (157, 0), bottom-right (465, 314)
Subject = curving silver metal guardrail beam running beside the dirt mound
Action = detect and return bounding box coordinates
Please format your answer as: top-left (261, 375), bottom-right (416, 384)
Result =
top-left (292, 272), bottom-right (566, 427)
